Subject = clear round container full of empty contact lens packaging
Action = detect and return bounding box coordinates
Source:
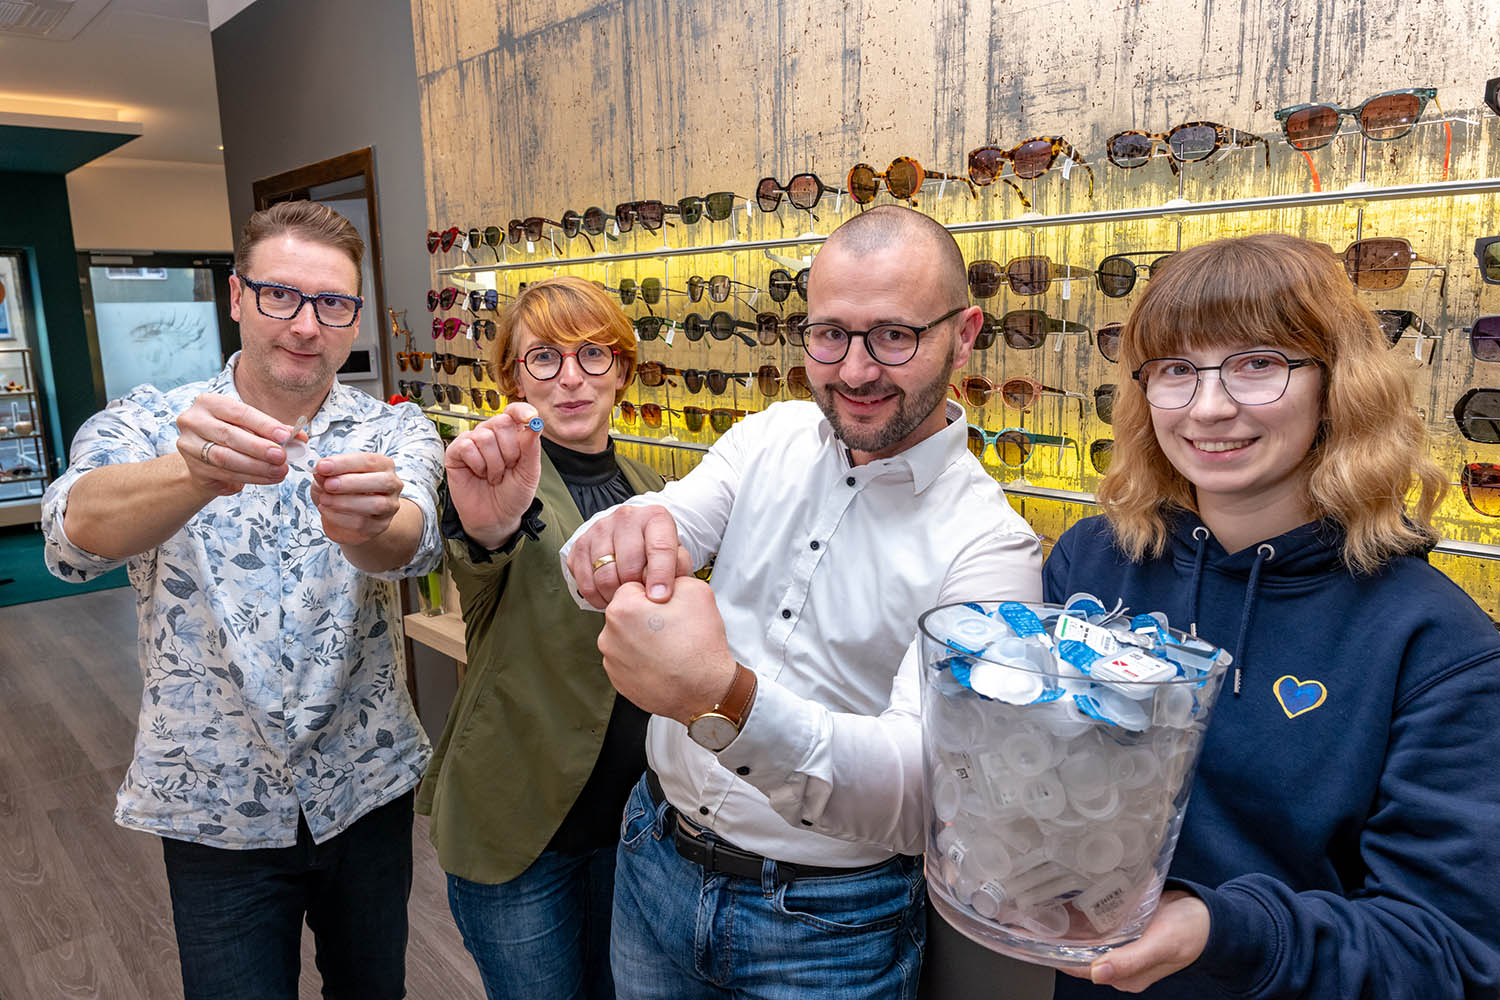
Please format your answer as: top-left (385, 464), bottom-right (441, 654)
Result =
top-left (921, 594), bottom-right (1230, 967)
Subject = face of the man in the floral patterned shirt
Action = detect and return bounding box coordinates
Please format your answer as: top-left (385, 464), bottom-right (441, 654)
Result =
top-left (230, 234), bottom-right (360, 412)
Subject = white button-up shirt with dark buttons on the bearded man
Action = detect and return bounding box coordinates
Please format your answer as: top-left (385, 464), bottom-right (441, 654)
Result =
top-left (561, 402), bottom-right (1041, 867)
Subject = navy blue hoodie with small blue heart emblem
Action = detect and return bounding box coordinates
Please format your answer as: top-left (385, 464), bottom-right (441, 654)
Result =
top-left (1043, 513), bottom-right (1500, 1000)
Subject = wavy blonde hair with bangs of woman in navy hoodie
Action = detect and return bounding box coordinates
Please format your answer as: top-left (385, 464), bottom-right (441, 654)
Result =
top-left (1098, 234), bottom-right (1448, 573)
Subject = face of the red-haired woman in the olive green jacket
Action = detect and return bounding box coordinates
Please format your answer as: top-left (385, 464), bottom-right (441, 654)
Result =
top-left (515, 321), bottom-right (629, 454)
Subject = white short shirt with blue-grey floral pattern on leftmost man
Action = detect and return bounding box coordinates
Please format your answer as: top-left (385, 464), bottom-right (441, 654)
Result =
top-left (42, 354), bottom-right (443, 849)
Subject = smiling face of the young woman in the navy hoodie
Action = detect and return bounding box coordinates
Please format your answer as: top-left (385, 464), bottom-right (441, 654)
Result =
top-left (1151, 343), bottom-right (1323, 538)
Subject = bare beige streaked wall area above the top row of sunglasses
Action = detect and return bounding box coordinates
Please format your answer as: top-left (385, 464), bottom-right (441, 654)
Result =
top-left (411, 0), bottom-right (1500, 219)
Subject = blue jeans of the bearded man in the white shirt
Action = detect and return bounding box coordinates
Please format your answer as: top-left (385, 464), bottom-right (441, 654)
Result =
top-left (611, 780), bottom-right (927, 1000)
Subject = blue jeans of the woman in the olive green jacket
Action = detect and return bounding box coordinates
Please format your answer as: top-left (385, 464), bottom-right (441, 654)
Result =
top-left (449, 847), bottom-right (615, 1000)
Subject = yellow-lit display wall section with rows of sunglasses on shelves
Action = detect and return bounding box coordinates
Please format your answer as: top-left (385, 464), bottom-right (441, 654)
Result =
top-left (423, 88), bottom-right (1500, 578)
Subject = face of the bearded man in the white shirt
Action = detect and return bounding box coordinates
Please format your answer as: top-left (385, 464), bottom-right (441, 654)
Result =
top-left (806, 243), bottom-right (983, 465)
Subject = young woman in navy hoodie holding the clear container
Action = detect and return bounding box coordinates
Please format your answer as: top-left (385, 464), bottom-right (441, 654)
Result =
top-left (1044, 234), bottom-right (1500, 1000)
